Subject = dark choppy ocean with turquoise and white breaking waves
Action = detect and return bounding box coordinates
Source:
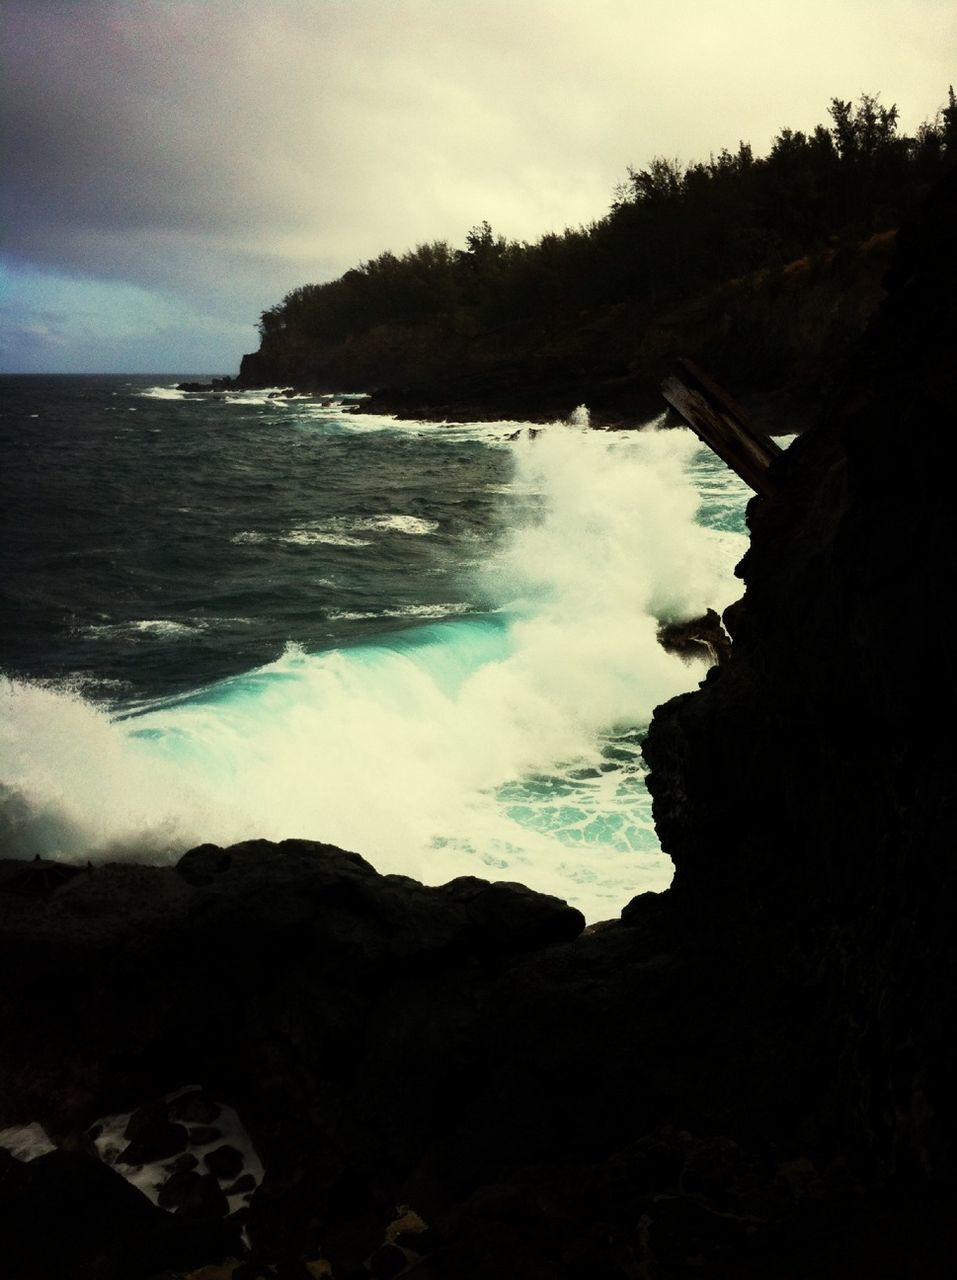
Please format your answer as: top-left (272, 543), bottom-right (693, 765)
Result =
top-left (0, 374), bottom-right (750, 920)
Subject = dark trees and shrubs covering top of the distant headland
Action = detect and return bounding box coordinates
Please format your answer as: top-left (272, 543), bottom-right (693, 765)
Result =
top-left (260, 88), bottom-right (957, 375)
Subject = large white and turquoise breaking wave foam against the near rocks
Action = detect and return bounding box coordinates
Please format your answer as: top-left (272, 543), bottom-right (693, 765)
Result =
top-left (0, 425), bottom-right (743, 919)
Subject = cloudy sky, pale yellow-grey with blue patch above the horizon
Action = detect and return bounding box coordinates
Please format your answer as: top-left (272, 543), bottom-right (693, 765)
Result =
top-left (0, 0), bottom-right (957, 372)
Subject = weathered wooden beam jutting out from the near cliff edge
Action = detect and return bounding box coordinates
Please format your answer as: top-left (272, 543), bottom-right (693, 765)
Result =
top-left (661, 360), bottom-right (782, 498)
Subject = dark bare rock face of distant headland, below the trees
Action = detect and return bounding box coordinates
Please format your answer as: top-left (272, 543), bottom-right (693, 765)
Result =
top-left (238, 232), bottom-right (893, 431)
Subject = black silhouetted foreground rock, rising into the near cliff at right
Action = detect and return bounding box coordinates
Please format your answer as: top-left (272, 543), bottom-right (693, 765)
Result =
top-left (0, 178), bottom-right (957, 1280)
